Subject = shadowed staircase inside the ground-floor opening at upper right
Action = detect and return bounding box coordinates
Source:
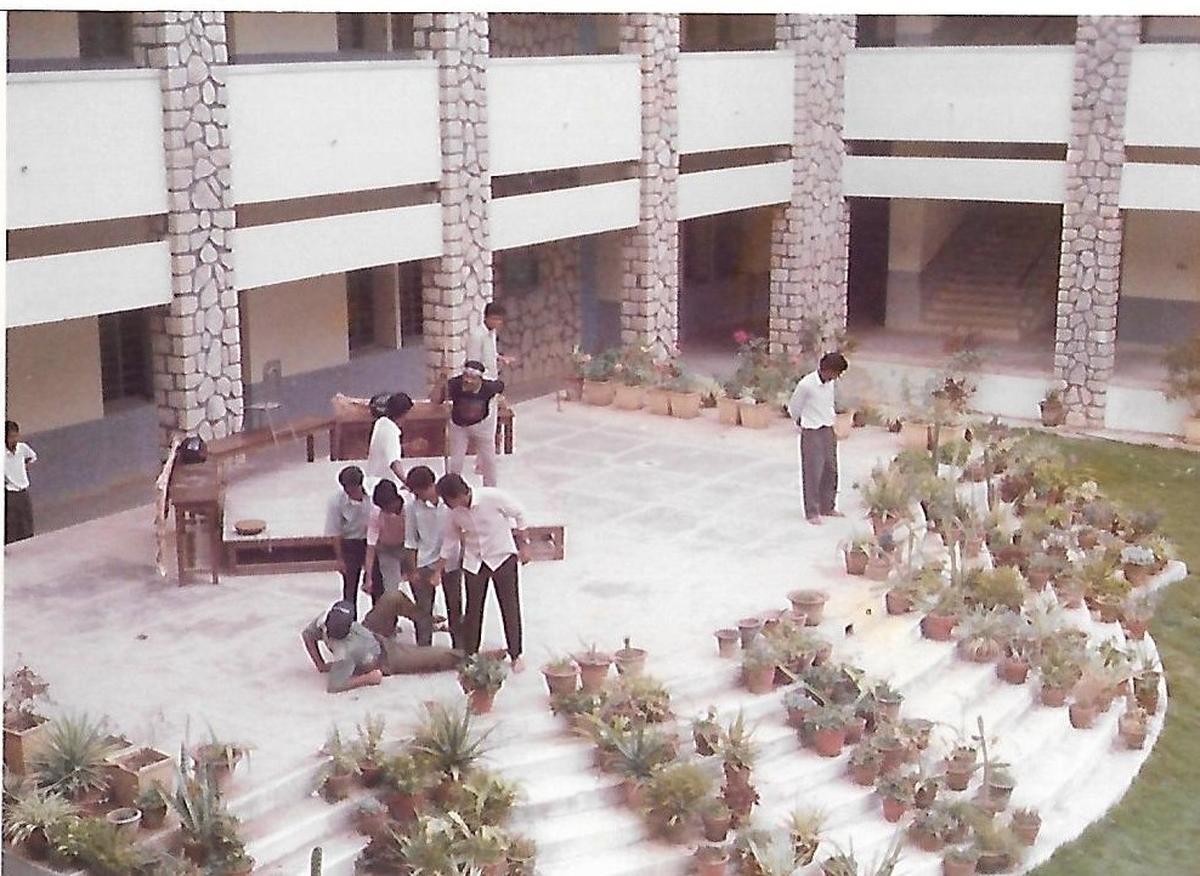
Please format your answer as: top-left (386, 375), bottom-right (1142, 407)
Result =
top-left (920, 205), bottom-right (1058, 341)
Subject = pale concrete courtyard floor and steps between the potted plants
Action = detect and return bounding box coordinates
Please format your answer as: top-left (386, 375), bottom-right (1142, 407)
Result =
top-left (4, 396), bottom-right (1159, 876)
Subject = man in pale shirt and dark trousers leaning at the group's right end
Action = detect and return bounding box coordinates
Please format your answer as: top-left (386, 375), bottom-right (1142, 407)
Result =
top-left (438, 474), bottom-right (529, 672)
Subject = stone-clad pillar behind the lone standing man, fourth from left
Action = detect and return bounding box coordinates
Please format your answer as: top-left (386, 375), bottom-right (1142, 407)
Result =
top-left (770, 13), bottom-right (854, 352)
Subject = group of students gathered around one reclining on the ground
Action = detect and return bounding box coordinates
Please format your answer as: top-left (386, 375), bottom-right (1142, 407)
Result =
top-left (302, 304), bottom-right (528, 692)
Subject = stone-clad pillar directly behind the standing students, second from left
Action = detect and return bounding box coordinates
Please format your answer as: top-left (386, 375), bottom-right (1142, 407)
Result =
top-left (413, 12), bottom-right (492, 383)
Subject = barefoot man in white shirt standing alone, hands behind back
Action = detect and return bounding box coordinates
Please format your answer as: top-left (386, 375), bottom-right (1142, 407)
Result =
top-left (787, 353), bottom-right (847, 524)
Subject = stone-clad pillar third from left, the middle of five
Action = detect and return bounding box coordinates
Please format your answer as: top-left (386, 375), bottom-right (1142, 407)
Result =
top-left (620, 12), bottom-right (679, 354)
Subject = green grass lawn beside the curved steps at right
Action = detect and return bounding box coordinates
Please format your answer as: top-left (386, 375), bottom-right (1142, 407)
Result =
top-left (1034, 440), bottom-right (1200, 876)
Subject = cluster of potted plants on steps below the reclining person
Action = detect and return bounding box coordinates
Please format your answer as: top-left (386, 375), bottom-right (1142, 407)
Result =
top-left (320, 703), bottom-right (536, 876)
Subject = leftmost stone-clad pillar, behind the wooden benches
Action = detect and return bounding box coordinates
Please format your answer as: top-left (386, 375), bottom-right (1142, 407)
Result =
top-left (133, 12), bottom-right (242, 446)
